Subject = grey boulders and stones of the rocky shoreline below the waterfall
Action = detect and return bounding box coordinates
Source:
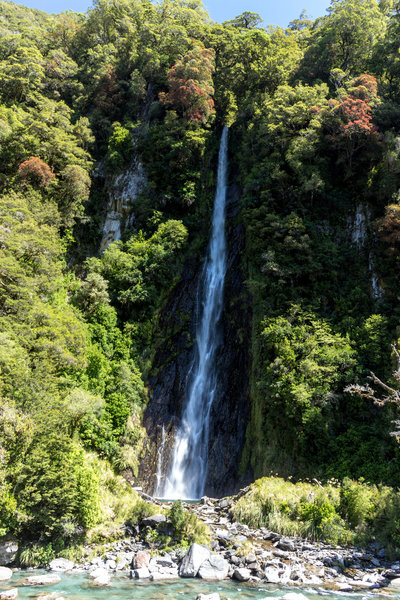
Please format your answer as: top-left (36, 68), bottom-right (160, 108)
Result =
top-left (0, 496), bottom-right (400, 600)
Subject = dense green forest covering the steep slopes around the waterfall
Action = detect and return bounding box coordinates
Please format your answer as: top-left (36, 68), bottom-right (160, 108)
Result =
top-left (0, 0), bottom-right (400, 553)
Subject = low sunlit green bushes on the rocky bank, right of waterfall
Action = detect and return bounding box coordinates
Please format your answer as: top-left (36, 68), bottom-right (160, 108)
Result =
top-left (232, 477), bottom-right (400, 553)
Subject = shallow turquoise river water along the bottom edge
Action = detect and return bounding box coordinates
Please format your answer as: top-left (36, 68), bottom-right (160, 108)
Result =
top-left (0, 570), bottom-right (399, 600)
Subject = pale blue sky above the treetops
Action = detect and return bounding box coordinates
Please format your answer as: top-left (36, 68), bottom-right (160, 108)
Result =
top-left (19, 0), bottom-right (329, 27)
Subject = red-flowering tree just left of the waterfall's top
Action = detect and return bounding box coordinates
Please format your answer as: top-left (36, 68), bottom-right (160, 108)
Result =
top-left (159, 48), bottom-right (215, 123)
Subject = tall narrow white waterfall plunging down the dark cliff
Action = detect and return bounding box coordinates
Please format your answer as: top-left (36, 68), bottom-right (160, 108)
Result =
top-left (156, 127), bottom-right (228, 499)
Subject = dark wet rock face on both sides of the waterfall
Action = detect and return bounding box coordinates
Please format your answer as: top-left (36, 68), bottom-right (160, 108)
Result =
top-left (138, 186), bottom-right (251, 496)
